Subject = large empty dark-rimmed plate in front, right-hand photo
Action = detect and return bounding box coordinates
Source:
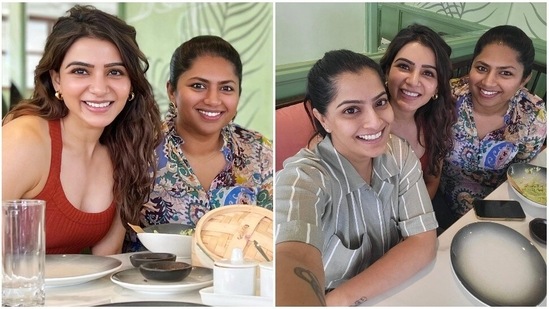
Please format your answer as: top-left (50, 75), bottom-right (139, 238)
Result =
top-left (450, 222), bottom-right (547, 306)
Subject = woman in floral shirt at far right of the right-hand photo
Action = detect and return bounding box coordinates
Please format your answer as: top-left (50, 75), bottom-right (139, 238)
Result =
top-left (434, 25), bottom-right (547, 228)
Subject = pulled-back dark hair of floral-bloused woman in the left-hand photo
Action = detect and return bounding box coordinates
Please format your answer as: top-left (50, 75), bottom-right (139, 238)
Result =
top-left (169, 35), bottom-right (242, 95)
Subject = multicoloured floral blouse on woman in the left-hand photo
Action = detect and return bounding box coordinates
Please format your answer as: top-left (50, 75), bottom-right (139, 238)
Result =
top-left (123, 107), bottom-right (274, 252)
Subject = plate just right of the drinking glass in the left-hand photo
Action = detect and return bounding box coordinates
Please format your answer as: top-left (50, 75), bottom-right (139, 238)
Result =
top-left (45, 254), bottom-right (122, 287)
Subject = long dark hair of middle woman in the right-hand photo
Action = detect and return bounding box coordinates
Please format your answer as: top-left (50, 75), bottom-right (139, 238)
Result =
top-left (380, 24), bottom-right (457, 175)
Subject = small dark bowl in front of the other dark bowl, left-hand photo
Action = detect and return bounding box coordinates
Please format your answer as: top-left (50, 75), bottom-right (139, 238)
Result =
top-left (139, 261), bottom-right (193, 281)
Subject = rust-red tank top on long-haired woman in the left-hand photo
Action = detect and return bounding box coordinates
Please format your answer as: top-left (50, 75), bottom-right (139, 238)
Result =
top-left (35, 120), bottom-right (116, 254)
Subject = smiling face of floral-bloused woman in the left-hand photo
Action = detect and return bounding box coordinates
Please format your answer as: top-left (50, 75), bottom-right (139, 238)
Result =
top-left (167, 55), bottom-right (240, 136)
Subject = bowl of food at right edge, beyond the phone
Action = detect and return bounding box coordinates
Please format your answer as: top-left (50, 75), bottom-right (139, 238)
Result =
top-left (507, 163), bottom-right (547, 209)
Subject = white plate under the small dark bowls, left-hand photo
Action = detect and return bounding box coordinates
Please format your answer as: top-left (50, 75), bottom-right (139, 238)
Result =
top-left (111, 267), bottom-right (213, 294)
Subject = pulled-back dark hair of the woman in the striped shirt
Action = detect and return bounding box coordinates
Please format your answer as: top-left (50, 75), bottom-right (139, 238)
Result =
top-left (303, 49), bottom-right (385, 140)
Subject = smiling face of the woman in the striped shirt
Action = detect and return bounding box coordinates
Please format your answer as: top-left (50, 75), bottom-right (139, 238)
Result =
top-left (314, 69), bottom-right (394, 166)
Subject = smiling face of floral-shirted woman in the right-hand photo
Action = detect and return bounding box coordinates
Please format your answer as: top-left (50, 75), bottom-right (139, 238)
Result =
top-left (469, 43), bottom-right (529, 110)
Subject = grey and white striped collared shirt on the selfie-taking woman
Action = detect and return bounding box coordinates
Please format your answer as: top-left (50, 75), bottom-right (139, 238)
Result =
top-left (275, 135), bottom-right (438, 289)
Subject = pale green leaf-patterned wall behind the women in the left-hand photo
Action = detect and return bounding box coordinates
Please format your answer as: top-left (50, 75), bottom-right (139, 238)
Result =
top-left (127, 2), bottom-right (274, 139)
